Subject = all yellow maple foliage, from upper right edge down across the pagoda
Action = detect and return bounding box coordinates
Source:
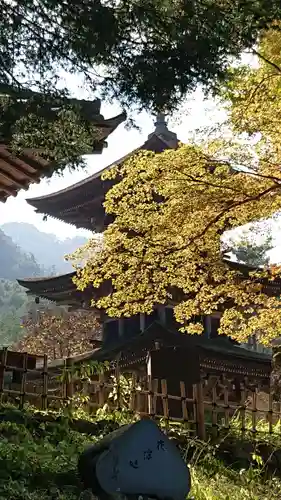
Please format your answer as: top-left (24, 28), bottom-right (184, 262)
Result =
top-left (69, 25), bottom-right (281, 344)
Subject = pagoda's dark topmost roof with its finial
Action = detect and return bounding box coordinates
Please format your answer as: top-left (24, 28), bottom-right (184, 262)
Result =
top-left (27, 114), bottom-right (178, 232)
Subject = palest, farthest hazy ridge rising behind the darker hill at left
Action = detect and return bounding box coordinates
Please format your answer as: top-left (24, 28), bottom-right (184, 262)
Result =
top-left (1, 222), bottom-right (87, 275)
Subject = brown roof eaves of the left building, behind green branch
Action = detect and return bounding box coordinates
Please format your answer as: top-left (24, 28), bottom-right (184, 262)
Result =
top-left (0, 94), bottom-right (126, 202)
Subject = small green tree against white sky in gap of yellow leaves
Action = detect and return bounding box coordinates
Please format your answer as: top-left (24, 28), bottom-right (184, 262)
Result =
top-left (223, 226), bottom-right (273, 267)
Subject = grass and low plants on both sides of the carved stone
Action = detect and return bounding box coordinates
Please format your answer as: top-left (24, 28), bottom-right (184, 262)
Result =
top-left (0, 408), bottom-right (281, 500)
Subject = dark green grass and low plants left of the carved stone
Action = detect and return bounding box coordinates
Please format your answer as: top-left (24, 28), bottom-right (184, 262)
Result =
top-left (0, 414), bottom-right (93, 500)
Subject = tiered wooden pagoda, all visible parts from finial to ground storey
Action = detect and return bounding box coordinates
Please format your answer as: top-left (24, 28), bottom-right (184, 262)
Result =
top-left (18, 115), bottom-right (276, 388)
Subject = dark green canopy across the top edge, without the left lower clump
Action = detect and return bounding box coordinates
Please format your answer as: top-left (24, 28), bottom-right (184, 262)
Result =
top-left (0, 0), bottom-right (281, 114)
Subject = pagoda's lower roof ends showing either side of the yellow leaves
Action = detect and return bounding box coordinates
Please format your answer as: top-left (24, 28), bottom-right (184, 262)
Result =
top-left (17, 260), bottom-right (281, 308)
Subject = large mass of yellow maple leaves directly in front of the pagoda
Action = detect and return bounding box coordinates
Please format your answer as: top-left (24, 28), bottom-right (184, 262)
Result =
top-left (70, 143), bottom-right (281, 343)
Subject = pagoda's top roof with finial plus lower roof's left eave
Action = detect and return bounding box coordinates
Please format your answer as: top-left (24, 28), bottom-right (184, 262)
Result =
top-left (18, 114), bottom-right (179, 309)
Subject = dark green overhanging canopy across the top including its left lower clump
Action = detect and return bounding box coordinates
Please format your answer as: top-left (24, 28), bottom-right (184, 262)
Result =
top-left (0, 0), bottom-right (281, 176)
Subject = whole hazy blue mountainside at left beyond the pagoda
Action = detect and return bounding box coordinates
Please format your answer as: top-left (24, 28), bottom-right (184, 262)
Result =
top-left (0, 222), bottom-right (87, 348)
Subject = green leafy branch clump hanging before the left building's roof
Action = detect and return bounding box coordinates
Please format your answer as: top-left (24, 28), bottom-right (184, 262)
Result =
top-left (0, 90), bottom-right (106, 177)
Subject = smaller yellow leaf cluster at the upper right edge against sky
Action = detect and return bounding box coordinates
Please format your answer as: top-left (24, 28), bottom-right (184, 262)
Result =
top-left (222, 23), bottom-right (281, 164)
